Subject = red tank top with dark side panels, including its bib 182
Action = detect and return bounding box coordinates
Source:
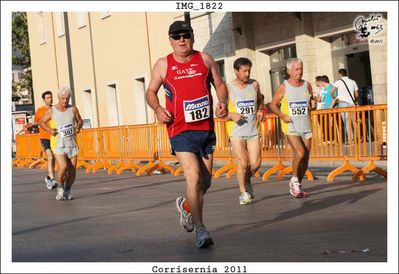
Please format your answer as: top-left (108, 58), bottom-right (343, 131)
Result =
top-left (163, 51), bottom-right (214, 138)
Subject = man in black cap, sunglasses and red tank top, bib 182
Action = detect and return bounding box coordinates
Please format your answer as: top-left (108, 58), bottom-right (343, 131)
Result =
top-left (146, 21), bottom-right (228, 248)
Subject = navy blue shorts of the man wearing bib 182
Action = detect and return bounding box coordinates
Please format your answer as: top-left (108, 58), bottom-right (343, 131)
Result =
top-left (170, 130), bottom-right (216, 157)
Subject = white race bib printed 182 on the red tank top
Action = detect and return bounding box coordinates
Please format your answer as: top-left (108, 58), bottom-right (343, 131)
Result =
top-left (183, 95), bottom-right (211, 123)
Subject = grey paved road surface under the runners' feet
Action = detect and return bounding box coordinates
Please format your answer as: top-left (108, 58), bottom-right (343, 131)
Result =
top-left (12, 167), bottom-right (387, 262)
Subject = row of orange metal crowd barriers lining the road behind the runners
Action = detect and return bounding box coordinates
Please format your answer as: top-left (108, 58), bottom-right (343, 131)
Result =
top-left (13, 105), bottom-right (388, 182)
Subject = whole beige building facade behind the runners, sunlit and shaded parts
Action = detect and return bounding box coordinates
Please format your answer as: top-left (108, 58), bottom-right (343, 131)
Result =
top-left (28, 12), bottom-right (388, 127)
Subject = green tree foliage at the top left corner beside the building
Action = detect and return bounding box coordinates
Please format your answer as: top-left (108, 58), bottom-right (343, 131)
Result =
top-left (12, 12), bottom-right (30, 68)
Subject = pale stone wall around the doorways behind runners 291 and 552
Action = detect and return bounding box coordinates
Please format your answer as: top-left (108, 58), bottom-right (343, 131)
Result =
top-left (232, 12), bottom-right (387, 103)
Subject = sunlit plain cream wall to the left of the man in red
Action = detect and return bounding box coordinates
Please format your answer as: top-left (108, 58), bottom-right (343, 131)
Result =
top-left (28, 12), bottom-right (181, 127)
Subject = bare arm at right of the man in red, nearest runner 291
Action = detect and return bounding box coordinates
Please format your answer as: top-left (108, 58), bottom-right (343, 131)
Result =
top-left (201, 52), bottom-right (229, 118)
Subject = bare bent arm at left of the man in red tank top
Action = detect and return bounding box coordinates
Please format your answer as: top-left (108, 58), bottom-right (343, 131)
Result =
top-left (146, 58), bottom-right (172, 123)
